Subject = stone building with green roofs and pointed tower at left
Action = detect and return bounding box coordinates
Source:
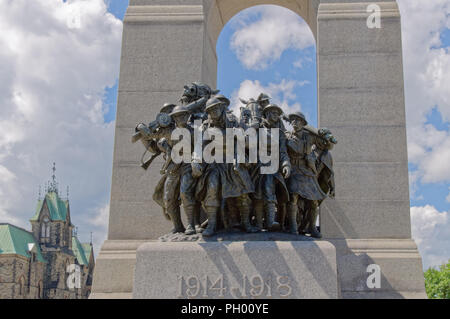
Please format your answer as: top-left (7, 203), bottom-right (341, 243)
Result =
top-left (0, 170), bottom-right (95, 299)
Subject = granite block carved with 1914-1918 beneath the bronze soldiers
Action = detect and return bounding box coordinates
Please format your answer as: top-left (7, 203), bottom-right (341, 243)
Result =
top-left (133, 241), bottom-right (339, 299)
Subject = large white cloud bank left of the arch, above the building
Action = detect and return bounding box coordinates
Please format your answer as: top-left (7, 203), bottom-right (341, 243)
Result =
top-left (0, 0), bottom-right (122, 248)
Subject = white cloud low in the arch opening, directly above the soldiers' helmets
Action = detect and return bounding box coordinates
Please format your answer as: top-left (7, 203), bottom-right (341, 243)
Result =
top-left (231, 79), bottom-right (309, 120)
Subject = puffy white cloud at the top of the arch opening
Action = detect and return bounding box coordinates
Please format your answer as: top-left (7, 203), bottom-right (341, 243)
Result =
top-left (230, 5), bottom-right (315, 70)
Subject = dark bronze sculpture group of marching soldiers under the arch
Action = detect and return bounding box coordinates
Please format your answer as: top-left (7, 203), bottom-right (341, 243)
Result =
top-left (133, 83), bottom-right (337, 238)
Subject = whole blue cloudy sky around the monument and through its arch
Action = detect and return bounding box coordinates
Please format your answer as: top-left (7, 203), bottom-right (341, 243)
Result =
top-left (0, 0), bottom-right (450, 267)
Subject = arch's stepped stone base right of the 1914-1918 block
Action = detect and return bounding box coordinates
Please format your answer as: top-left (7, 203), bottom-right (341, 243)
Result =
top-left (330, 239), bottom-right (426, 298)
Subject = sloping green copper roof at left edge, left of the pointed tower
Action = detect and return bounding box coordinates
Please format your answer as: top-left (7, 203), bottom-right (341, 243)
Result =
top-left (0, 224), bottom-right (46, 262)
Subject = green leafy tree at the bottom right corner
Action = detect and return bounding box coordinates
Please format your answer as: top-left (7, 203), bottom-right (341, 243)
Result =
top-left (425, 260), bottom-right (450, 299)
